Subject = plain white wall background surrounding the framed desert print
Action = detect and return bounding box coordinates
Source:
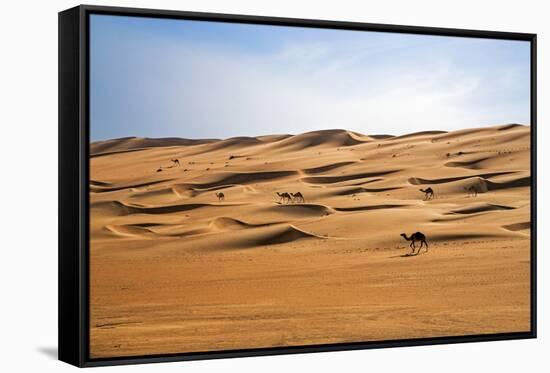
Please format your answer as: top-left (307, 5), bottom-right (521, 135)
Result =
top-left (0, 0), bottom-right (550, 373)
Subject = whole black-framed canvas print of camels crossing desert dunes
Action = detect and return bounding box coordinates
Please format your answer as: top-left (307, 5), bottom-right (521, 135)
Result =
top-left (59, 6), bottom-right (536, 367)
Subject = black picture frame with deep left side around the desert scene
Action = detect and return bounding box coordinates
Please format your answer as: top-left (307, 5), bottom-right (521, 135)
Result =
top-left (58, 5), bottom-right (537, 367)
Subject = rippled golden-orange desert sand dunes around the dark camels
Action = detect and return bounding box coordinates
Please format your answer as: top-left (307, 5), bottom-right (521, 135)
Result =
top-left (90, 125), bottom-right (530, 358)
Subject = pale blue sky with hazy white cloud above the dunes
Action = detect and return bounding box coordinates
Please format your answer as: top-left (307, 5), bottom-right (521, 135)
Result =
top-left (90, 15), bottom-right (530, 141)
